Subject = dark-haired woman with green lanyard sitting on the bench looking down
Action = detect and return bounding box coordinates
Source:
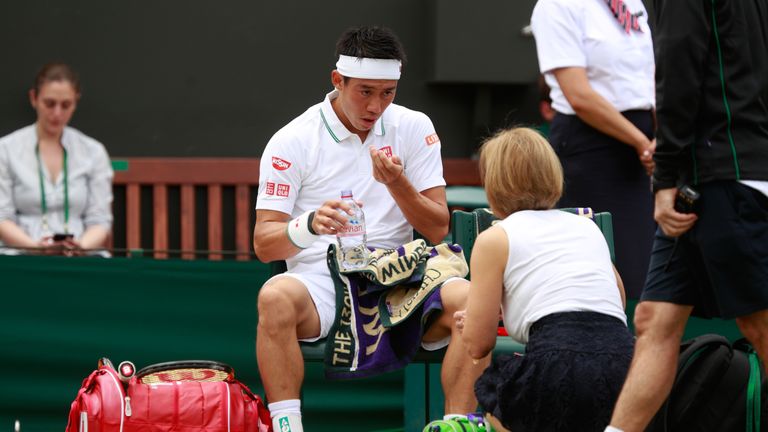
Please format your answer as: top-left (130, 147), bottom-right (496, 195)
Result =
top-left (0, 63), bottom-right (112, 255)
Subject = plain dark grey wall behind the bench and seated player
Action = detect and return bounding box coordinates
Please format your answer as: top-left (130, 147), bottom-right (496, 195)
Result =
top-left (0, 0), bottom-right (560, 157)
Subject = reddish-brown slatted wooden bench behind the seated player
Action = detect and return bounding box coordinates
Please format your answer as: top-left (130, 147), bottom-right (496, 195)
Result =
top-left (112, 158), bottom-right (480, 260)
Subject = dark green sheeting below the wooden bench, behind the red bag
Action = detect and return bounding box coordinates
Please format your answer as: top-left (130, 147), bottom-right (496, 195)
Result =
top-left (0, 256), bottom-right (403, 432)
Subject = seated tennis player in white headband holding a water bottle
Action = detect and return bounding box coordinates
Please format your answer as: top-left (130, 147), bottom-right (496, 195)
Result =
top-left (253, 27), bottom-right (487, 432)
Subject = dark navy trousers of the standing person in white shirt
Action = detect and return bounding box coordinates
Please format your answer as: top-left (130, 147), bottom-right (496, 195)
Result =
top-left (549, 111), bottom-right (656, 298)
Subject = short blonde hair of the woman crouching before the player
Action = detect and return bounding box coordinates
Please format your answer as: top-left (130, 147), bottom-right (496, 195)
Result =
top-left (480, 128), bottom-right (563, 218)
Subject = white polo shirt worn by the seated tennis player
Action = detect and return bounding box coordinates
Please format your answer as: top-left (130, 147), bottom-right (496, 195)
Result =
top-left (256, 90), bottom-right (445, 271)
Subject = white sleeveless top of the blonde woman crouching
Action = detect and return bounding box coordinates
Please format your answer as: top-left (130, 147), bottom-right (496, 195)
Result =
top-left (498, 210), bottom-right (627, 343)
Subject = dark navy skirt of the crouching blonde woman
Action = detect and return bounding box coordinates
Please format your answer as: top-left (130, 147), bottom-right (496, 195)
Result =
top-left (475, 312), bottom-right (634, 432)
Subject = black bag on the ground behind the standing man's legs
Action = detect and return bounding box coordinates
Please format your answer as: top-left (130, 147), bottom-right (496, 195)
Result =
top-left (646, 334), bottom-right (768, 432)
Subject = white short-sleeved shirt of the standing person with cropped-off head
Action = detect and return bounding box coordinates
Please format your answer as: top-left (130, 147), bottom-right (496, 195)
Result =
top-left (531, 0), bottom-right (656, 114)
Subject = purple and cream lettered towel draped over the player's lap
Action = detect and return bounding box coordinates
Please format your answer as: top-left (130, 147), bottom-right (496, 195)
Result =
top-left (325, 240), bottom-right (469, 379)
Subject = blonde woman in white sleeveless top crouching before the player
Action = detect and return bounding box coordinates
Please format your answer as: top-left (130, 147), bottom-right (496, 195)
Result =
top-left (454, 128), bottom-right (633, 432)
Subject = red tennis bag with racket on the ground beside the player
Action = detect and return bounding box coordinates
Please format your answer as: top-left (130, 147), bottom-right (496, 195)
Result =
top-left (66, 359), bottom-right (272, 432)
